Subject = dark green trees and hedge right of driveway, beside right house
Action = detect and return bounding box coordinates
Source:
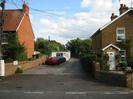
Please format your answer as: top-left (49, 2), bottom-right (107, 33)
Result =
top-left (66, 38), bottom-right (97, 73)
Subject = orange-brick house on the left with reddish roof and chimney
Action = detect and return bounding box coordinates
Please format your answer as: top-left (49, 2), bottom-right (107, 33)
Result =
top-left (3, 3), bottom-right (34, 58)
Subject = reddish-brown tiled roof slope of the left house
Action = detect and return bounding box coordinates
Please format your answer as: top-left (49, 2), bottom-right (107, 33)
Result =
top-left (0, 9), bottom-right (24, 31)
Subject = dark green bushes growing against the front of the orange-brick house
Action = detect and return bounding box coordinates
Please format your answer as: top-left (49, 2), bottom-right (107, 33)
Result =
top-left (2, 32), bottom-right (27, 62)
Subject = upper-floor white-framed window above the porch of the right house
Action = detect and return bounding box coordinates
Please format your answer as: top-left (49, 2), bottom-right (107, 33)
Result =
top-left (116, 28), bottom-right (126, 42)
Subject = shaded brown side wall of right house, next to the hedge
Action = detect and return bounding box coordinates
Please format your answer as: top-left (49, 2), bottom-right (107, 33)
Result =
top-left (92, 32), bottom-right (102, 53)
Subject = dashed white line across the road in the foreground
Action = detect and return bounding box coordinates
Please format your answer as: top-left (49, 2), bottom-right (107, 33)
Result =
top-left (0, 90), bottom-right (133, 95)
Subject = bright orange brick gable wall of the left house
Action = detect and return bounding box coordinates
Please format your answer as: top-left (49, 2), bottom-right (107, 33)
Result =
top-left (17, 15), bottom-right (34, 58)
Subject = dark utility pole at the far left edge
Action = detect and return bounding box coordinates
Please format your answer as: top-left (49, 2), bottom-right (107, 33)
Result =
top-left (0, 0), bottom-right (5, 60)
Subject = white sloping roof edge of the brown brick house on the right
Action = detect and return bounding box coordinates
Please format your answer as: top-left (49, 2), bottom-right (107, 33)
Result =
top-left (91, 8), bottom-right (133, 38)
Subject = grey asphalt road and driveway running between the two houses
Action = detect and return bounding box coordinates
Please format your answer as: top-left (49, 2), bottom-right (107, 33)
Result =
top-left (0, 59), bottom-right (133, 99)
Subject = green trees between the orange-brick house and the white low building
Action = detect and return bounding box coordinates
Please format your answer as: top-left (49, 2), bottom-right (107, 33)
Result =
top-left (35, 38), bottom-right (65, 55)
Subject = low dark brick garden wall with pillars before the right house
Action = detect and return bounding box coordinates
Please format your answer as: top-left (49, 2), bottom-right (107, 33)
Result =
top-left (93, 62), bottom-right (133, 89)
